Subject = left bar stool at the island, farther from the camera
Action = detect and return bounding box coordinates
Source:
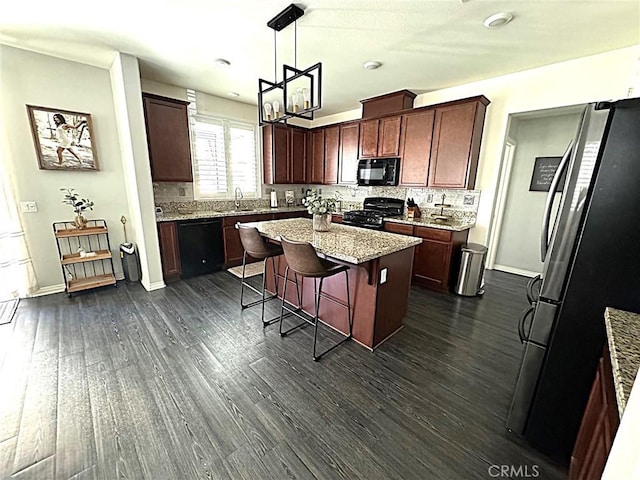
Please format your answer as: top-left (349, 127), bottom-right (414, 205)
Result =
top-left (236, 224), bottom-right (282, 327)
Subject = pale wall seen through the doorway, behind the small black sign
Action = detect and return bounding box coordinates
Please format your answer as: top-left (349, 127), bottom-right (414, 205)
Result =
top-left (495, 114), bottom-right (580, 274)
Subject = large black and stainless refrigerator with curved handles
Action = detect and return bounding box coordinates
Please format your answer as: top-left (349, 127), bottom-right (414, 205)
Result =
top-left (507, 99), bottom-right (640, 462)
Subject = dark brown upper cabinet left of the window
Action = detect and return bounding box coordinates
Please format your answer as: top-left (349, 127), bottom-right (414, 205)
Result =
top-left (142, 93), bottom-right (193, 182)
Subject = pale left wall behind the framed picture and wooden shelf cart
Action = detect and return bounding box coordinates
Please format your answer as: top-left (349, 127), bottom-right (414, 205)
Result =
top-left (0, 45), bottom-right (129, 292)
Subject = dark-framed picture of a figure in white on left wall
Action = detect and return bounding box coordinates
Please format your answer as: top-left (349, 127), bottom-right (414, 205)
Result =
top-left (27, 105), bottom-right (99, 171)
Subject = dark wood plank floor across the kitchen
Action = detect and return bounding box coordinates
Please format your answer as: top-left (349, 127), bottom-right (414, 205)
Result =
top-left (0, 272), bottom-right (566, 480)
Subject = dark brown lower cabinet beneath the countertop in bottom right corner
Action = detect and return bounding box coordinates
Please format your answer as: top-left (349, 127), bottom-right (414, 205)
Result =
top-left (569, 347), bottom-right (620, 480)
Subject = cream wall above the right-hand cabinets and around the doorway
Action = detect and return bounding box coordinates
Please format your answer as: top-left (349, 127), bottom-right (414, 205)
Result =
top-left (313, 44), bottom-right (640, 249)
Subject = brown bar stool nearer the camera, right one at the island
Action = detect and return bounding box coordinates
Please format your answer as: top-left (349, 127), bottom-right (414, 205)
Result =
top-left (280, 237), bottom-right (353, 362)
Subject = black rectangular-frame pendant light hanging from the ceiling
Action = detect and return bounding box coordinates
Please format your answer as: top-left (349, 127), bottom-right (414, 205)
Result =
top-left (258, 3), bottom-right (322, 125)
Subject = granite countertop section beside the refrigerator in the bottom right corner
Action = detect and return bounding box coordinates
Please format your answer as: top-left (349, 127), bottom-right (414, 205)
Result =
top-left (604, 307), bottom-right (640, 418)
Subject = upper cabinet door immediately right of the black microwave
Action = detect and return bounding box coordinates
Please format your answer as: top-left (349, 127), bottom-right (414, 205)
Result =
top-left (400, 110), bottom-right (435, 187)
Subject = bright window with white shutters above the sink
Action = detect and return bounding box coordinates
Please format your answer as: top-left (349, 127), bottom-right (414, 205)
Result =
top-left (191, 115), bottom-right (260, 199)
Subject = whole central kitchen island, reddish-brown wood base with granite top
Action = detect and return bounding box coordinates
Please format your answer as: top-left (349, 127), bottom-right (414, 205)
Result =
top-left (242, 218), bottom-right (421, 350)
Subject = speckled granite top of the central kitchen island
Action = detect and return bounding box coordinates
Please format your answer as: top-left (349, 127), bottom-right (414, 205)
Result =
top-left (244, 218), bottom-right (422, 264)
